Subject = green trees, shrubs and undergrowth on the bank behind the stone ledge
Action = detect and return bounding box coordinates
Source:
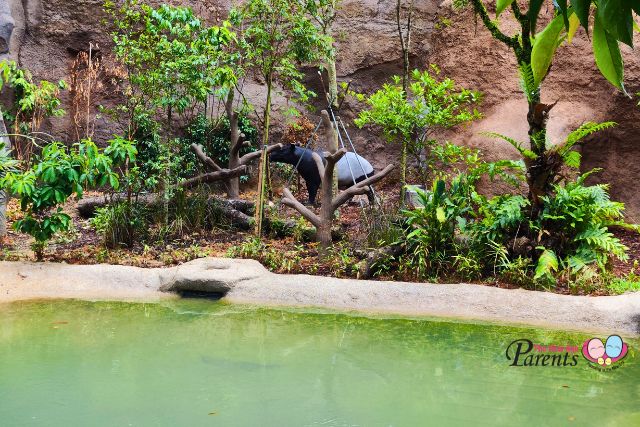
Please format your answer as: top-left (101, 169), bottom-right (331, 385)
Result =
top-left (0, 0), bottom-right (640, 293)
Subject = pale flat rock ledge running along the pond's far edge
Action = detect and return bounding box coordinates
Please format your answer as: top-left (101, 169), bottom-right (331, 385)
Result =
top-left (0, 258), bottom-right (640, 337)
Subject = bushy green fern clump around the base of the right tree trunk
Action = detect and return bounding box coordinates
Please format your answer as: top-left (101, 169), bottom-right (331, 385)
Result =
top-left (473, 174), bottom-right (633, 284)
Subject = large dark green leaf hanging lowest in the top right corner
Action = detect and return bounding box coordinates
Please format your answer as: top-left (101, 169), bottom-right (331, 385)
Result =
top-left (593, 14), bottom-right (626, 93)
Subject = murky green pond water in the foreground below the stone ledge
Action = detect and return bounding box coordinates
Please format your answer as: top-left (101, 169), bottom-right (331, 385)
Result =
top-left (0, 300), bottom-right (640, 427)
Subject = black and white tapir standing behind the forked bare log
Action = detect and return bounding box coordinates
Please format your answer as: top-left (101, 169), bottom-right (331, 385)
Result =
top-left (269, 144), bottom-right (375, 204)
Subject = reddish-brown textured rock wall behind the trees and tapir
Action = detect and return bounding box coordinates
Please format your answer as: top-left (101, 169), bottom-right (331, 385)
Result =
top-left (0, 0), bottom-right (640, 220)
